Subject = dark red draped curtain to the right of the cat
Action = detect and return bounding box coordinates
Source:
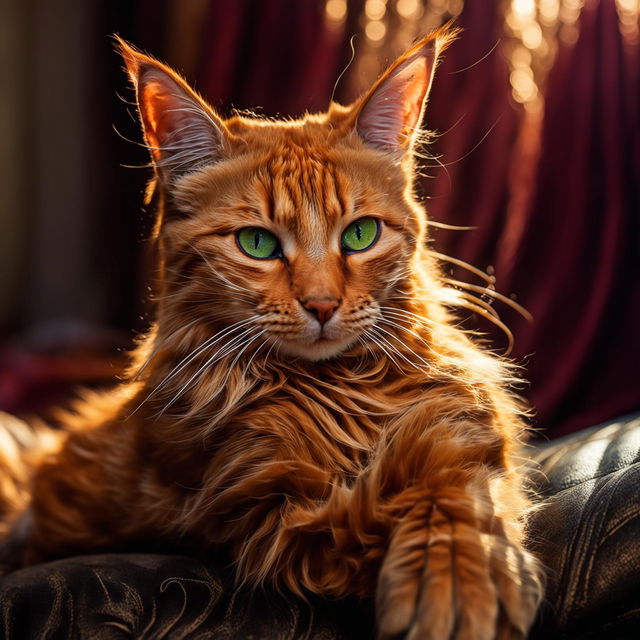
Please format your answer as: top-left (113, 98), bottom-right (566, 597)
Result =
top-left (425, 0), bottom-right (640, 436)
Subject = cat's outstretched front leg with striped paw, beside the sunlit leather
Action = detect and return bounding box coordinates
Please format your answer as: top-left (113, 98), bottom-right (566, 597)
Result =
top-left (375, 412), bottom-right (542, 640)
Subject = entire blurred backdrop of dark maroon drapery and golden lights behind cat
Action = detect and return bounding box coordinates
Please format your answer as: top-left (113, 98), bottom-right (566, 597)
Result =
top-left (0, 0), bottom-right (640, 437)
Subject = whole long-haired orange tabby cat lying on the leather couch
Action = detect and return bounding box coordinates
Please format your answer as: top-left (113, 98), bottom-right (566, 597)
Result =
top-left (0, 33), bottom-right (540, 640)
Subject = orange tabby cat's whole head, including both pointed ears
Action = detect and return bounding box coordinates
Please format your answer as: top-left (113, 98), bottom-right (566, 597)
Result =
top-left (120, 30), bottom-right (451, 360)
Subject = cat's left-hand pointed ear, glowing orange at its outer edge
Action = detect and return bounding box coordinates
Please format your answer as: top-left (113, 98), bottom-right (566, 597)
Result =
top-left (116, 36), bottom-right (228, 182)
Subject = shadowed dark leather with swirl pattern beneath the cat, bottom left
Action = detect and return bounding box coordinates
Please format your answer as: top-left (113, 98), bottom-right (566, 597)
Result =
top-left (0, 553), bottom-right (373, 640)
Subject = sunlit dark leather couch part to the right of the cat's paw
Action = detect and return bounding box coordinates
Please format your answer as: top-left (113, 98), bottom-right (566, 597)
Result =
top-left (531, 416), bottom-right (640, 640)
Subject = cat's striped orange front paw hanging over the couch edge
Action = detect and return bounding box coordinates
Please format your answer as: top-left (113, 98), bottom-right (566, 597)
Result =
top-left (376, 504), bottom-right (541, 640)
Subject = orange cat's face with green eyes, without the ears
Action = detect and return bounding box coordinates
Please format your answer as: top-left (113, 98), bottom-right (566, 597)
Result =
top-left (162, 122), bottom-right (420, 360)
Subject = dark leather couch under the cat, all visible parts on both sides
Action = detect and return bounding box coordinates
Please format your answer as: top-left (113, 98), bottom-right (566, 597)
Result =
top-left (0, 416), bottom-right (640, 640)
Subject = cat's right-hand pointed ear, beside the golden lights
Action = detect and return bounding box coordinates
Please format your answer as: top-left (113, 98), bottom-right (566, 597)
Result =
top-left (355, 25), bottom-right (457, 153)
